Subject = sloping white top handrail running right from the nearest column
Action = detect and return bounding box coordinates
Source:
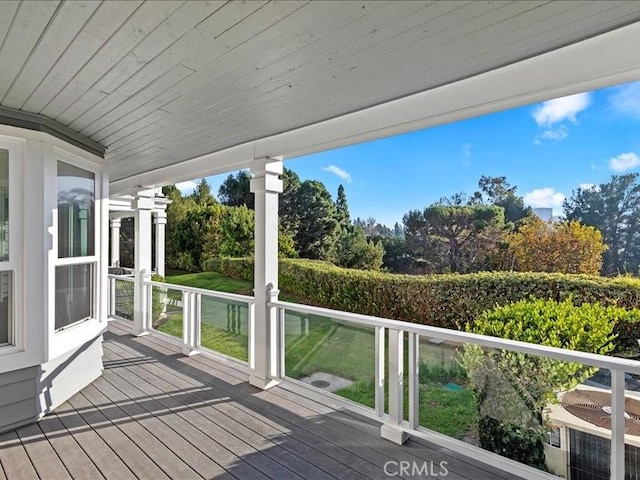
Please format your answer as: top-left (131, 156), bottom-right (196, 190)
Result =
top-left (269, 301), bottom-right (640, 375)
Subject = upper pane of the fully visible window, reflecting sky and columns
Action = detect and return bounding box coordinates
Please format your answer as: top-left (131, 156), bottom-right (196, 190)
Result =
top-left (58, 162), bottom-right (96, 258)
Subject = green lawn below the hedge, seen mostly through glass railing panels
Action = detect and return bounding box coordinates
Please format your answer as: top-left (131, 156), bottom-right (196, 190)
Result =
top-left (162, 272), bottom-right (477, 439)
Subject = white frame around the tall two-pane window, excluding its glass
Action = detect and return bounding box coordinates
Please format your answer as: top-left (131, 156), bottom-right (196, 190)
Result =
top-left (52, 148), bottom-right (103, 334)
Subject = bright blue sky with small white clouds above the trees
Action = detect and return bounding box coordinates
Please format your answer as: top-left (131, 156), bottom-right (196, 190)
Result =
top-left (179, 82), bottom-right (640, 226)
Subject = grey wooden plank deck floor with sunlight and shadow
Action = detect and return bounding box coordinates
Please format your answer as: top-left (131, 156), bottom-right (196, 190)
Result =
top-left (0, 323), bottom-right (528, 480)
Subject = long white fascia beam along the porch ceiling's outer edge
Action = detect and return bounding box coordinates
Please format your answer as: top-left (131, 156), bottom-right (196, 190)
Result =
top-left (111, 18), bottom-right (640, 194)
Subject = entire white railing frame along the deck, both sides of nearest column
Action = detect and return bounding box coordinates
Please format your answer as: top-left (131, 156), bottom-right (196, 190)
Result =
top-left (109, 275), bottom-right (640, 480)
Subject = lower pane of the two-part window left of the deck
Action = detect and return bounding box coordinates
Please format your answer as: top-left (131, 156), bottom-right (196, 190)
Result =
top-left (56, 263), bottom-right (94, 330)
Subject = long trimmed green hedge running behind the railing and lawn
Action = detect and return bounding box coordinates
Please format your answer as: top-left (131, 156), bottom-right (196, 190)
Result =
top-left (206, 258), bottom-right (640, 348)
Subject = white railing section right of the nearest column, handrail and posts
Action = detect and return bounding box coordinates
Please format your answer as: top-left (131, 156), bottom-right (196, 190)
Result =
top-left (269, 301), bottom-right (640, 480)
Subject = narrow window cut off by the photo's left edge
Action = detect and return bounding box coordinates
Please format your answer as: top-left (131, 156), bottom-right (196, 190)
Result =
top-left (0, 149), bottom-right (13, 347)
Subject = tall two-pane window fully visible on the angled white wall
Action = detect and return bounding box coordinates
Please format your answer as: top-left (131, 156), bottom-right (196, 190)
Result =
top-left (55, 161), bottom-right (96, 330)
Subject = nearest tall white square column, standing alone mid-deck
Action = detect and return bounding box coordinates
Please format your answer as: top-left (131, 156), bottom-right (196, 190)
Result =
top-left (249, 158), bottom-right (282, 389)
